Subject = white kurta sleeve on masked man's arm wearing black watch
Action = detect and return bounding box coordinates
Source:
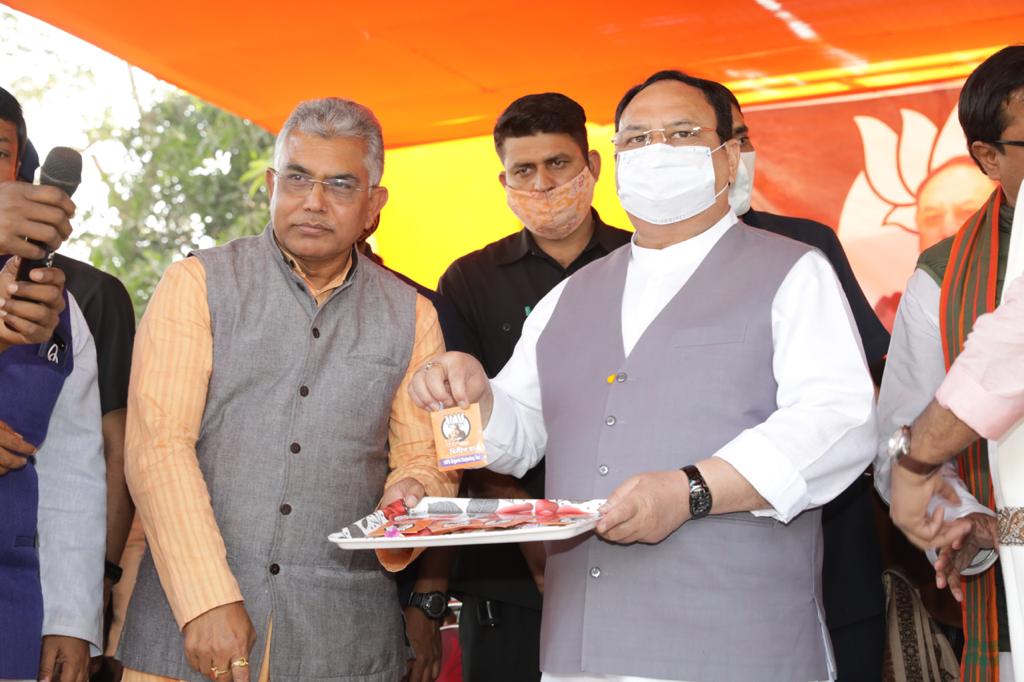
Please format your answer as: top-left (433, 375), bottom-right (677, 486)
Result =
top-left (715, 251), bottom-right (876, 522)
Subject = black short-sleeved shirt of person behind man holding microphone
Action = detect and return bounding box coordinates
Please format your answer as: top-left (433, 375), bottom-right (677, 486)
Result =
top-left (53, 254), bottom-right (135, 415)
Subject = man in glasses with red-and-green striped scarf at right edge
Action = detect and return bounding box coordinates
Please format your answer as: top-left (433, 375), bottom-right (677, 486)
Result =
top-left (876, 45), bottom-right (1024, 680)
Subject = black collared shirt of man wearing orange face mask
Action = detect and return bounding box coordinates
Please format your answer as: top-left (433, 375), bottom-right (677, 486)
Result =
top-left (437, 209), bottom-right (632, 608)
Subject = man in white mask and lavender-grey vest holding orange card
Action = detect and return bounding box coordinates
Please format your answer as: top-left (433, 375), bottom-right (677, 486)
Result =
top-left (410, 71), bottom-right (874, 682)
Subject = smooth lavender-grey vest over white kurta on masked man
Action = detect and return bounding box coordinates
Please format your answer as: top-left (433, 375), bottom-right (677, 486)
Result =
top-left (537, 223), bottom-right (828, 682)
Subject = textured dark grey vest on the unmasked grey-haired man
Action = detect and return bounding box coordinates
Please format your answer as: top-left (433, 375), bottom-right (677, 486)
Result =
top-left (120, 227), bottom-right (416, 682)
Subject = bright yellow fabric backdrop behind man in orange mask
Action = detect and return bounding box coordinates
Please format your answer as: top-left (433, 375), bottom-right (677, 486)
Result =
top-left (374, 125), bottom-right (632, 289)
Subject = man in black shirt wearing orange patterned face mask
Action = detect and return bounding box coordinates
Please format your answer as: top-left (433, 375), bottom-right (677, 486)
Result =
top-left (437, 92), bottom-right (630, 682)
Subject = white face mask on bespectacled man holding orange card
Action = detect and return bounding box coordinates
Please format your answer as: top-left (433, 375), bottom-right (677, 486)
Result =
top-left (615, 143), bottom-right (729, 225)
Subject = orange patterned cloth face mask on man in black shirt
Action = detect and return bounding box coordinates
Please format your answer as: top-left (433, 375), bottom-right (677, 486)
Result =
top-left (505, 166), bottom-right (596, 241)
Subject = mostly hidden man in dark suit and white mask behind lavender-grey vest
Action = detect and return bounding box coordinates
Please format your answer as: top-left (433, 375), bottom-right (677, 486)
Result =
top-left (708, 80), bottom-right (889, 680)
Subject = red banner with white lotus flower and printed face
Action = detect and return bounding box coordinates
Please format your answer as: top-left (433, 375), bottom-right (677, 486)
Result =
top-left (745, 83), bottom-right (995, 330)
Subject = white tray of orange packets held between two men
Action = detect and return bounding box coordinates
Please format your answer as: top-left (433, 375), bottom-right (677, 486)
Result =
top-left (328, 498), bottom-right (604, 550)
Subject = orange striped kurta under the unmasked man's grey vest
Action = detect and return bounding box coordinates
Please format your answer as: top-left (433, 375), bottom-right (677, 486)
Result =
top-left (124, 254), bottom-right (458, 682)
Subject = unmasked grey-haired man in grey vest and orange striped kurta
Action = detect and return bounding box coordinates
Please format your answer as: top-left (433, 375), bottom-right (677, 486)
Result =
top-left (120, 98), bottom-right (458, 682)
